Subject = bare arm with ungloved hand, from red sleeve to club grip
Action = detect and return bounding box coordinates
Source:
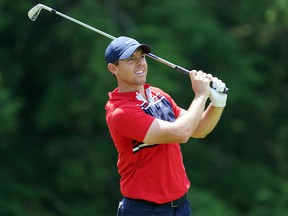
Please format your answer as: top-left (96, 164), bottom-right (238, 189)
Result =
top-left (143, 71), bottom-right (212, 144)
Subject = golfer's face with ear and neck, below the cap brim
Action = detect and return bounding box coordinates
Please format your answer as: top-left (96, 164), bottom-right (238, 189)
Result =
top-left (108, 48), bottom-right (148, 92)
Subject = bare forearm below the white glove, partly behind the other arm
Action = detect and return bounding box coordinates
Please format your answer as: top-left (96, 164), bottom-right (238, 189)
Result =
top-left (191, 104), bottom-right (224, 138)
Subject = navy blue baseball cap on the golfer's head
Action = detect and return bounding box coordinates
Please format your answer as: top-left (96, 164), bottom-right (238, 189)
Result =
top-left (105, 36), bottom-right (151, 64)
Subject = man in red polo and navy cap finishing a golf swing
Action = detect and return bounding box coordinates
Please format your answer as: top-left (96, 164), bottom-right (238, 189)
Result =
top-left (105, 36), bottom-right (227, 216)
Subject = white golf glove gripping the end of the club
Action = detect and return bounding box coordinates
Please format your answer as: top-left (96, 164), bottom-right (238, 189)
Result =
top-left (210, 77), bottom-right (227, 107)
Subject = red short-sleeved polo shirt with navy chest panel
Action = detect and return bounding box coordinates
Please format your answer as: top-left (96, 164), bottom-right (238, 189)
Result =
top-left (105, 84), bottom-right (190, 204)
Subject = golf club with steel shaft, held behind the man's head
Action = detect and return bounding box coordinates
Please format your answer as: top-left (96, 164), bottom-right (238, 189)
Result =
top-left (28, 4), bottom-right (229, 94)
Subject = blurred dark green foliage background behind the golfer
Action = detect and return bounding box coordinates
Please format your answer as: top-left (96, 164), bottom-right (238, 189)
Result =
top-left (0, 0), bottom-right (288, 216)
